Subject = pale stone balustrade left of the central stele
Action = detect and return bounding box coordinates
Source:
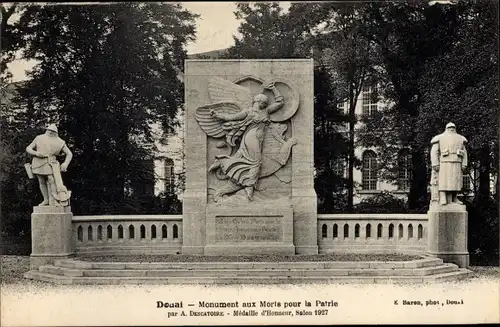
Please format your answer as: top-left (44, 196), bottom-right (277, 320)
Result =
top-left (73, 215), bottom-right (182, 255)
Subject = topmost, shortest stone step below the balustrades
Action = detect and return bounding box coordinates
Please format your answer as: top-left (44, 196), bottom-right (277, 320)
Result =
top-left (55, 258), bottom-right (443, 270)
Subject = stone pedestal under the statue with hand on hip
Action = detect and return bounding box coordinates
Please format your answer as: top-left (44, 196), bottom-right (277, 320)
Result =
top-left (30, 206), bottom-right (73, 270)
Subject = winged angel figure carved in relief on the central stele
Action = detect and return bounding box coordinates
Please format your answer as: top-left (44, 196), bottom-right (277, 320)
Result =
top-left (196, 78), bottom-right (298, 202)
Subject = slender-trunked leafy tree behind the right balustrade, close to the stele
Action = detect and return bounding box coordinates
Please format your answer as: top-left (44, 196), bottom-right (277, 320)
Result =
top-left (290, 2), bottom-right (378, 211)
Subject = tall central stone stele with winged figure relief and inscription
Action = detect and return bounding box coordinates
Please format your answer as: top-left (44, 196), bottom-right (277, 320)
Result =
top-left (182, 59), bottom-right (318, 255)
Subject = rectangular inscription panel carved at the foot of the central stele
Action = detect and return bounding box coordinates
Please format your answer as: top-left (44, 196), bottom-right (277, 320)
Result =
top-left (215, 216), bottom-right (283, 243)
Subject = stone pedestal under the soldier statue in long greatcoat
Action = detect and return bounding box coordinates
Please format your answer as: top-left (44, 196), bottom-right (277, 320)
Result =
top-left (428, 204), bottom-right (469, 268)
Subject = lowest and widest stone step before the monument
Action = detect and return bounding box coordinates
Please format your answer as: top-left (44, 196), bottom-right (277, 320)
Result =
top-left (24, 269), bottom-right (470, 285)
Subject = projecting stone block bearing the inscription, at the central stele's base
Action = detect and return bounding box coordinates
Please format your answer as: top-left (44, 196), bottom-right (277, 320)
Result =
top-left (205, 203), bottom-right (295, 255)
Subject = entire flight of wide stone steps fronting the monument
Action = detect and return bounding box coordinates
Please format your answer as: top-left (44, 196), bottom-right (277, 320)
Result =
top-left (24, 257), bottom-right (472, 284)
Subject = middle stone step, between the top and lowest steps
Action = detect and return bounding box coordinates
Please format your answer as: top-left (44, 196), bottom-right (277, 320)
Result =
top-left (40, 264), bottom-right (458, 278)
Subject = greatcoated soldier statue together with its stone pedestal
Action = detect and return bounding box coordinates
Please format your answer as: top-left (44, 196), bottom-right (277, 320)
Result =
top-left (428, 123), bottom-right (469, 268)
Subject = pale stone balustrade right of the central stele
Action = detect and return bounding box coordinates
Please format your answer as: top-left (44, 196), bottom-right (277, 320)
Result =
top-left (318, 214), bottom-right (428, 254)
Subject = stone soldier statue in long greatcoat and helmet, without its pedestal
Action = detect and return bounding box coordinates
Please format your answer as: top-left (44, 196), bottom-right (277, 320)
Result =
top-left (431, 123), bottom-right (467, 205)
